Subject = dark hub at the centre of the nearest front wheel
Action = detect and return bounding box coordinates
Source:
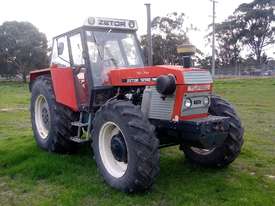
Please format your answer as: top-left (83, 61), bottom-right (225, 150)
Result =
top-left (111, 133), bottom-right (127, 163)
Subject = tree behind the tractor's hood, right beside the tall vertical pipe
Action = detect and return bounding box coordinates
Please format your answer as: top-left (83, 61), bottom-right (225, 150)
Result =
top-left (141, 12), bottom-right (191, 65)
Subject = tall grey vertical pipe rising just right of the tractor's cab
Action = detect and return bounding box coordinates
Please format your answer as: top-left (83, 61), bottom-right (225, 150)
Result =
top-left (144, 3), bottom-right (153, 66)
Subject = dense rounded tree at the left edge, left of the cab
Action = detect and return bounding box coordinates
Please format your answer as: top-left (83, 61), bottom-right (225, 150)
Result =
top-left (0, 21), bottom-right (48, 82)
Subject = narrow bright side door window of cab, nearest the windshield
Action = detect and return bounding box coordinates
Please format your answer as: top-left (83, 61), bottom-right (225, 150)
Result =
top-left (70, 34), bottom-right (85, 65)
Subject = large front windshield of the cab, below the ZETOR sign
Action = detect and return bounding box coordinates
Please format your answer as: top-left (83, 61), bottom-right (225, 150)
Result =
top-left (87, 30), bottom-right (144, 86)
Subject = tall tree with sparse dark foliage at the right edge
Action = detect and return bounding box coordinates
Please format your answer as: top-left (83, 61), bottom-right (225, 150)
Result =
top-left (234, 0), bottom-right (275, 64)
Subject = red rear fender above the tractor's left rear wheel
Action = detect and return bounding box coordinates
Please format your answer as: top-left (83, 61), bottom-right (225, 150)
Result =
top-left (30, 66), bottom-right (79, 111)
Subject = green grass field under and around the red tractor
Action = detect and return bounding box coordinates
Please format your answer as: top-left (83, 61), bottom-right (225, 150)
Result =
top-left (0, 79), bottom-right (275, 206)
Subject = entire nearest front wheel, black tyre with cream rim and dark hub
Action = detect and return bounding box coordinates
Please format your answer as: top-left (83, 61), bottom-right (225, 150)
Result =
top-left (92, 100), bottom-right (159, 192)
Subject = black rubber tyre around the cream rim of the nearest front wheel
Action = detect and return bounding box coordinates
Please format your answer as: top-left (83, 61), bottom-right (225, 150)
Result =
top-left (92, 100), bottom-right (159, 192)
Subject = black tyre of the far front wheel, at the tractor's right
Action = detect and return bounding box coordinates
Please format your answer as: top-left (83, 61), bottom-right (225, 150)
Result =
top-left (181, 96), bottom-right (244, 167)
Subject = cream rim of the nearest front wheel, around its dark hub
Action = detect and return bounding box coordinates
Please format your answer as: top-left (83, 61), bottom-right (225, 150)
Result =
top-left (98, 122), bottom-right (128, 178)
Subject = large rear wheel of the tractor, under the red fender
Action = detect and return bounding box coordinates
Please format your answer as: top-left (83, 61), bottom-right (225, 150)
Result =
top-left (31, 76), bottom-right (78, 153)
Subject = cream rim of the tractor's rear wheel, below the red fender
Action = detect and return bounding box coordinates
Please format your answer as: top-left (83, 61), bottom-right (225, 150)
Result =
top-left (34, 95), bottom-right (51, 139)
